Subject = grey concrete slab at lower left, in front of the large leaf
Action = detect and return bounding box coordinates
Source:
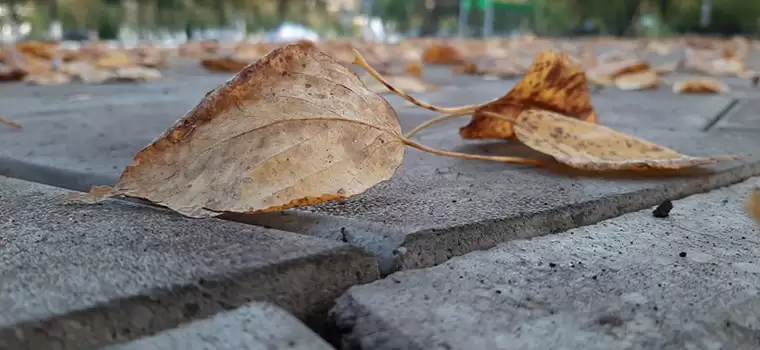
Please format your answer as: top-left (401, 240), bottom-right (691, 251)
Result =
top-left (0, 177), bottom-right (378, 349)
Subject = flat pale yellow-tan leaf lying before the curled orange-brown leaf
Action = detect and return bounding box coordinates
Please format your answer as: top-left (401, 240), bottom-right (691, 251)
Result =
top-left (489, 110), bottom-right (738, 171)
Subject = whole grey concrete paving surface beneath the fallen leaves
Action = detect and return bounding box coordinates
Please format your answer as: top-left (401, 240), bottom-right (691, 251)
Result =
top-left (0, 56), bottom-right (760, 349)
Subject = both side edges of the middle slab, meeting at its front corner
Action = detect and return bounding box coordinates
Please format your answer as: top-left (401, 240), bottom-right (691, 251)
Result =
top-left (240, 163), bottom-right (760, 276)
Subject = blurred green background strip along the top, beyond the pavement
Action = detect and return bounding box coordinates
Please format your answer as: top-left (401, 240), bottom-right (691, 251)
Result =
top-left (0, 0), bottom-right (760, 45)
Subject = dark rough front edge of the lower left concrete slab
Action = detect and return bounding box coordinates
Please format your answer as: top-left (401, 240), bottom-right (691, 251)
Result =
top-left (0, 175), bottom-right (380, 349)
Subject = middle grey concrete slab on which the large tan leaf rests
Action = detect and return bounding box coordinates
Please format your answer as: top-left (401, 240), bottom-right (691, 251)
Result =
top-left (0, 74), bottom-right (760, 273)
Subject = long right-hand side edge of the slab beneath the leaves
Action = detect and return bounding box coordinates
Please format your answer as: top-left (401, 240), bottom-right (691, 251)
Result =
top-left (394, 163), bottom-right (760, 272)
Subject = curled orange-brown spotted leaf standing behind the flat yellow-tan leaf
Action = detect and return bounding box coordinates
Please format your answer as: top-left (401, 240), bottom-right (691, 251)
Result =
top-left (459, 51), bottom-right (598, 139)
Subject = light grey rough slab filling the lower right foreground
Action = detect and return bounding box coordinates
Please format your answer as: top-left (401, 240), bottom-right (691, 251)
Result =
top-left (331, 178), bottom-right (760, 350)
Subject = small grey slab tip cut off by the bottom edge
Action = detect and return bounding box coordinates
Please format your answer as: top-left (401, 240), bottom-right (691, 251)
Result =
top-left (102, 303), bottom-right (334, 350)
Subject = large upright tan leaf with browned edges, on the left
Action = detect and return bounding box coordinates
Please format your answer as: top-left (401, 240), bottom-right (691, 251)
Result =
top-left (70, 44), bottom-right (405, 217)
